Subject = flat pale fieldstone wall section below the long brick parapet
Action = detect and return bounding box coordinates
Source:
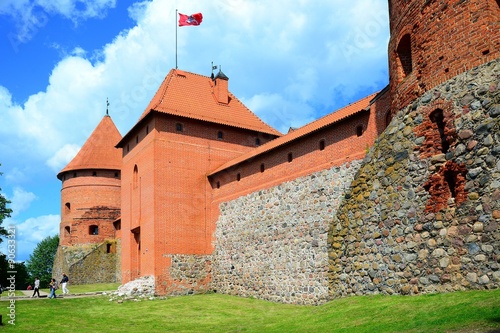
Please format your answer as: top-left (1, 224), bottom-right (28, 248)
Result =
top-left (212, 161), bottom-right (360, 304)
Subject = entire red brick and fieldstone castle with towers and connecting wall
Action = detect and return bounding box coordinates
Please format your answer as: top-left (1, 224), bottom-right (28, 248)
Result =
top-left (54, 0), bottom-right (500, 304)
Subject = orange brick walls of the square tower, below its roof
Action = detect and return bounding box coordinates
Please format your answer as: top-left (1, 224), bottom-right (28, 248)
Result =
top-left (121, 113), bottom-right (280, 294)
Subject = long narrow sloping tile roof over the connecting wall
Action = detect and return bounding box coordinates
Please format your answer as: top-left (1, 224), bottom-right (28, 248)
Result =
top-left (209, 93), bottom-right (377, 176)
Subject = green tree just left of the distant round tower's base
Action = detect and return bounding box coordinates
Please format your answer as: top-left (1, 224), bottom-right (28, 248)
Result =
top-left (26, 235), bottom-right (59, 284)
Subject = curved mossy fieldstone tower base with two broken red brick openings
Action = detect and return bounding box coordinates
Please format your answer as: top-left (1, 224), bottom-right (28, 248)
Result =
top-left (328, 60), bottom-right (500, 297)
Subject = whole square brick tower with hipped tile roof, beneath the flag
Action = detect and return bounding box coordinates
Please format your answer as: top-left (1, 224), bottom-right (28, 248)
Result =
top-left (117, 69), bottom-right (280, 294)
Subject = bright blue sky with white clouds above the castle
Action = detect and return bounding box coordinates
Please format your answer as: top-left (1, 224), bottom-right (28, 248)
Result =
top-left (0, 0), bottom-right (389, 261)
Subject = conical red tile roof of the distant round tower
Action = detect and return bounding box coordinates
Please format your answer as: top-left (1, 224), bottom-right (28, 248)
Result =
top-left (57, 115), bottom-right (122, 179)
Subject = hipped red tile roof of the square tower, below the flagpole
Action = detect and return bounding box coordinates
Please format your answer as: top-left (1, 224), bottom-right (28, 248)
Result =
top-left (140, 69), bottom-right (282, 136)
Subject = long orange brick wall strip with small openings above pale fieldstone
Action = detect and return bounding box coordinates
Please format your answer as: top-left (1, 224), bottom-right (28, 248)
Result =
top-left (210, 93), bottom-right (389, 205)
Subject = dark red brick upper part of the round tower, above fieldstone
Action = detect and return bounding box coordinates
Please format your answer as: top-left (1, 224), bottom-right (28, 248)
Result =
top-left (389, 0), bottom-right (500, 113)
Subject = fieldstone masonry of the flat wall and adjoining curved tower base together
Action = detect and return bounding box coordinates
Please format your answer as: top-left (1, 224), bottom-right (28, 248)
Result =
top-left (212, 60), bottom-right (500, 304)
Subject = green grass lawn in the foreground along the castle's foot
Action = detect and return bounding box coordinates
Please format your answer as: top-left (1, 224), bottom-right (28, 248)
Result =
top-left (0, 290), bottom-right (500, 333)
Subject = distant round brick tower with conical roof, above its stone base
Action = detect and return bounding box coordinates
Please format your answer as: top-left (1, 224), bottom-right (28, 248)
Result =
top-left (57, 115), bottom-right (121, 246)
